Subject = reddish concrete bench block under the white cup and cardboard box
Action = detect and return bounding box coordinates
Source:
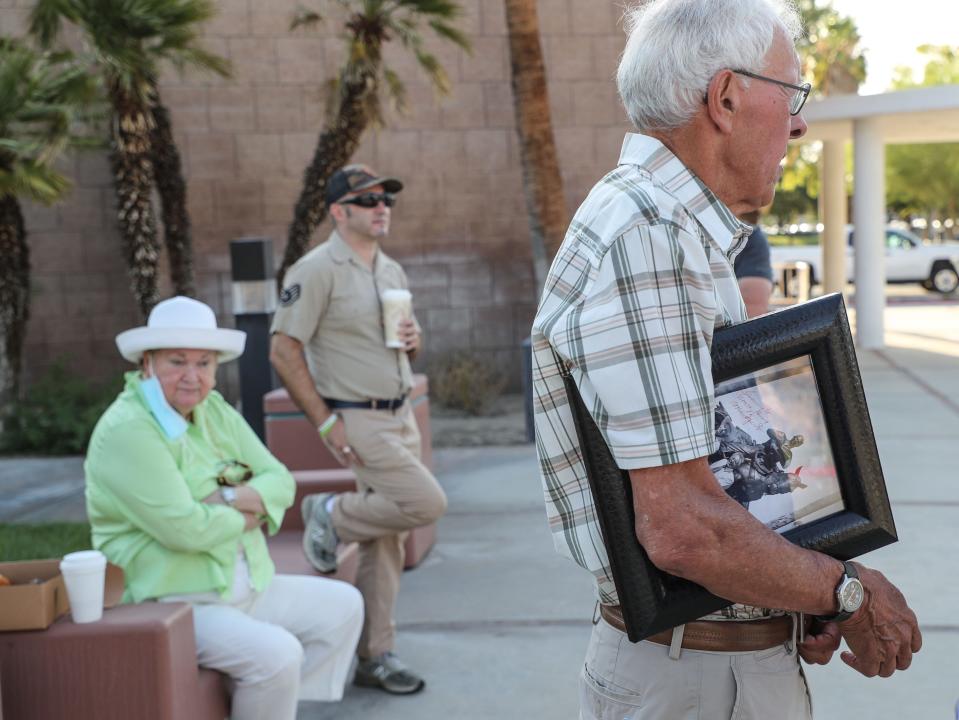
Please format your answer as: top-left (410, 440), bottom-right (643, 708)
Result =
top-left (0, 603), bottom-right (230, 720)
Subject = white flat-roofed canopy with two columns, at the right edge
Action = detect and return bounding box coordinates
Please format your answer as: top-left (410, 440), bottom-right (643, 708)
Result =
top-left (803, 85), bottom-right (959, 349)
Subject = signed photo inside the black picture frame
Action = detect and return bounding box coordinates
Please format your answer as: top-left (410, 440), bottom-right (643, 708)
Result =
top-left (709, 357), bottom-right (843, 532)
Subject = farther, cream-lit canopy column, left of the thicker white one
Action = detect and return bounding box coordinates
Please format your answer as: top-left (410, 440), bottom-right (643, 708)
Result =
top-left (818, 140), bottom-right (848, 293)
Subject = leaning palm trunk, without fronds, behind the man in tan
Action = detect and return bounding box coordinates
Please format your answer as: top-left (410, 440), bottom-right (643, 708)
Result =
top-left (276, 74), bottom-right (376, 289)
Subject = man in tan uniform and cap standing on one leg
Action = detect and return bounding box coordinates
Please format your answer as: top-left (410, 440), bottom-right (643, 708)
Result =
top-left (270, 165), bottom-right (446, 694)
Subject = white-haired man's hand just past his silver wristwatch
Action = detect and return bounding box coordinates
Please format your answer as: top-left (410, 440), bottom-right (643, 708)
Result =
top-left (839, 563), bottom-right (922, 677)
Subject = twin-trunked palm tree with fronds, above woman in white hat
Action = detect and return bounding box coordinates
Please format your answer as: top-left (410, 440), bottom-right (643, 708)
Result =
top-left (31, 0), bottom-right (229, 314)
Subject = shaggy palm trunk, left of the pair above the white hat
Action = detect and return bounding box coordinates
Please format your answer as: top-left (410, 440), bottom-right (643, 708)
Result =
top-left (110, 93), bottom-right (160, 316)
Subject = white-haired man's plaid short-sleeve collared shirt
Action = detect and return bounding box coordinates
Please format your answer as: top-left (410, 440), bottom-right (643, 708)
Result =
top-left (532, 135), bottom-right (768, 618)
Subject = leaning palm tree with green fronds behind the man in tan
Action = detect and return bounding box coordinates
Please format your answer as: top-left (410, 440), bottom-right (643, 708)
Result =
top-left (277, 0), bottom-right (470, 285)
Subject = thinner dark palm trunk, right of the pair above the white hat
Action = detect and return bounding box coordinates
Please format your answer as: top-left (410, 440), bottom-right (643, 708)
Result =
top-left (150, 93), bottom-right (196, 297)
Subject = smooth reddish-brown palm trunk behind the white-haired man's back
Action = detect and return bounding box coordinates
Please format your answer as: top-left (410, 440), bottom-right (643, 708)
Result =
top-left (506, 0), bottom-right (569, 289)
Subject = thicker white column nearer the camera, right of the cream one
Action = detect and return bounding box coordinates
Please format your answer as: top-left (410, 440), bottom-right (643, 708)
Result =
top-left (853, 118), bottom-right (886, 350)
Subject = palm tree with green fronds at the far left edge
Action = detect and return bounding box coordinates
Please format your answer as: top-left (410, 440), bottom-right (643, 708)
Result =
top-left (0, 39), bottom-right (96, 407)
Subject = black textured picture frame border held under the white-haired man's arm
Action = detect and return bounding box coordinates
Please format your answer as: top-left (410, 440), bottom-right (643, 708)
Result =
top-left (564, 294), bottom-right (898, 642)
